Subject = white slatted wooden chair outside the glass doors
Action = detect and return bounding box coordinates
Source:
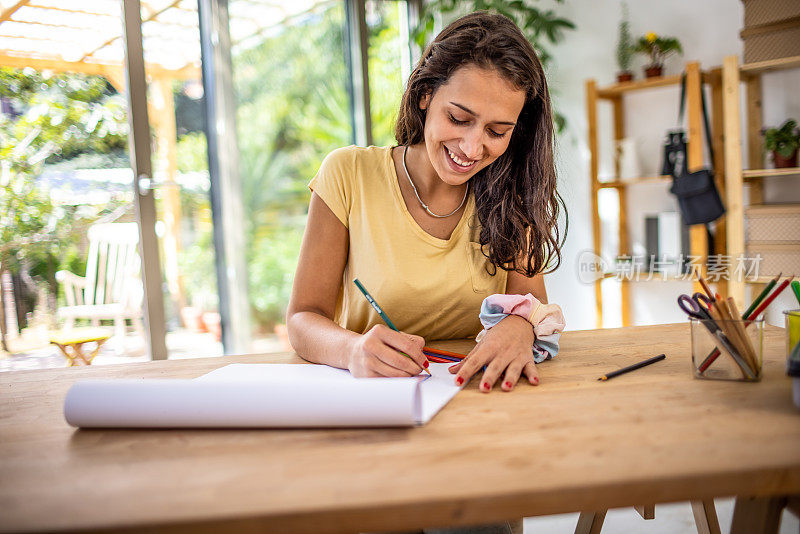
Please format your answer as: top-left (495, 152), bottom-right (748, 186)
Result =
top-left (56, 223), bottom-right (144, 354)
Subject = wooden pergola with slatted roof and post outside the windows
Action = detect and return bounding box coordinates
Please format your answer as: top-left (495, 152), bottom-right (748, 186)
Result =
top-left (0, 0), bottom-right (330, 318)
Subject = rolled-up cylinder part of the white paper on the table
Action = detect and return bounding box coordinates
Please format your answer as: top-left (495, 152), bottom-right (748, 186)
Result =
top-left (64, 379), bottom-right (416, 428)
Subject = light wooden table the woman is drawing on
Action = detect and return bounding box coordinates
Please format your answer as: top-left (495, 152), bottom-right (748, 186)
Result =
top-left (0, 325), bottom-right (800, 533)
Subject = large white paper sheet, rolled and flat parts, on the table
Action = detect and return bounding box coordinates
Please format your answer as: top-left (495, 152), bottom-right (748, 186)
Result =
top-left (64, 363), bottom-right (460, 428)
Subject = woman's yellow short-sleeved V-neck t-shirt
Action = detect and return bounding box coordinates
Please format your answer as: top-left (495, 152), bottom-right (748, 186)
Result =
top-left (308, 146), bottom-right (508, 340)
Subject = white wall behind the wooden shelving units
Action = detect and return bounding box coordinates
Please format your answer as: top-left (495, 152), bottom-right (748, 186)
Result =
top-left (540, 0), bottom-right (800, 329)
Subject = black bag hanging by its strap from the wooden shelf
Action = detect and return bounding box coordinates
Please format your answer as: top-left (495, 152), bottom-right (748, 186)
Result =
top-left (664, 74), bottom-right (725, 225)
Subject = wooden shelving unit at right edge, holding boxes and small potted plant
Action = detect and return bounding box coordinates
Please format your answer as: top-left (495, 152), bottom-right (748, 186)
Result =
top-left (722, 56), bottom-right (800, 305)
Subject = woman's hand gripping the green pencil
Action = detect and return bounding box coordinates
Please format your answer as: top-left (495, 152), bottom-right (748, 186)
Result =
top-left (347, 324), bottom-right (428, 378)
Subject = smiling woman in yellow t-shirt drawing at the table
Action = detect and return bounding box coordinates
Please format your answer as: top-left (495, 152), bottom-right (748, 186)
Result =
top-left (287, 12), bottom-right (563, 406)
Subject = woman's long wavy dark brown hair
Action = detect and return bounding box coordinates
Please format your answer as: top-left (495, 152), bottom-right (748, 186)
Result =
top-left (395, 11), bottom-right (566, 276)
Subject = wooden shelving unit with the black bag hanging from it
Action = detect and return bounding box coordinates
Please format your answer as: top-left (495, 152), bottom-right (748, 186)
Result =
top-left (586, 62), bottom-right (724, 328)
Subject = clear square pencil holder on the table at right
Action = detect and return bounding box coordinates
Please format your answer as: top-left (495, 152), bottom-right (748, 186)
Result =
top-left (691, 319), bottom-right (764, 382)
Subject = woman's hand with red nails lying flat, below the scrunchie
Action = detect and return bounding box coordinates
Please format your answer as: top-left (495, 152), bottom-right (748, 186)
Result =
top-left (450, 315), bottom-right (539, 393)
